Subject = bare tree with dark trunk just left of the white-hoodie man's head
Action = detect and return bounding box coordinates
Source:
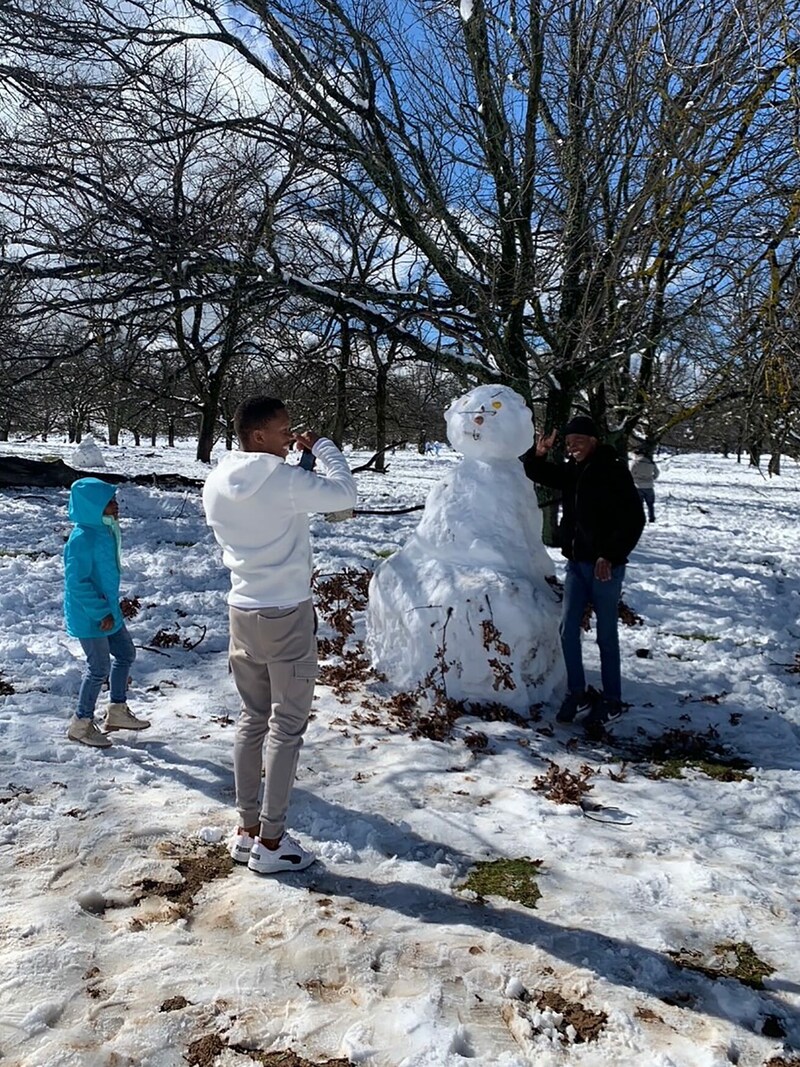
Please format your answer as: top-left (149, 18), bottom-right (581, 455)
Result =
top-left (2, 15), bottom-right (315, 460)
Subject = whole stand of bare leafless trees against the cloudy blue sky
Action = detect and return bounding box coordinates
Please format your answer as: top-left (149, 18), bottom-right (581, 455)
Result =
top-left (0, 0), bottom-right (800, 482)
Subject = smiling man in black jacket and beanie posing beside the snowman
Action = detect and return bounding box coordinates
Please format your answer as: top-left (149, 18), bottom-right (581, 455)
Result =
top-left (523, 415), bottom-right (644, 733)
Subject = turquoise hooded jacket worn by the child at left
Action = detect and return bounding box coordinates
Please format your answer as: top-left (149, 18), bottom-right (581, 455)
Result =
top-left (64, 478), bottom-right (125, 639)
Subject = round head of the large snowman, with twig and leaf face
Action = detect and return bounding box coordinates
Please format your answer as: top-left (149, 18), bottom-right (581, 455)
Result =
top-left (445, 385), bottom-right (533, 460)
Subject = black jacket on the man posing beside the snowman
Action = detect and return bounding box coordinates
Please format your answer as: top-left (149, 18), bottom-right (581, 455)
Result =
top-left (523, 445), bottom-right (644, 566)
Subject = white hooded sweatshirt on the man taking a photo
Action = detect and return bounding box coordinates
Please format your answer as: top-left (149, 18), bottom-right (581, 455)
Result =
top-left (203, 437), bottom-right (357, 608)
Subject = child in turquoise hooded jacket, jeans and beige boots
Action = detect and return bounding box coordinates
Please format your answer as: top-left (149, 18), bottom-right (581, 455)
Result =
top-left (64, 478), bottom-right (150, 748)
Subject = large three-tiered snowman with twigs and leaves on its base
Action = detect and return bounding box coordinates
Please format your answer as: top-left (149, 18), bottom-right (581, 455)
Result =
top-left (367, 385), bottom-right (564, 714)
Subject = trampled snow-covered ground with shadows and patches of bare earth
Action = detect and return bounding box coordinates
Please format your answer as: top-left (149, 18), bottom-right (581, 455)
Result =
top-left (0, 443), bottom-right (800, 1067)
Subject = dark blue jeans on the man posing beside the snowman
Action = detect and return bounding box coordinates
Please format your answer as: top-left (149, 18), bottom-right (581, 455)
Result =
top-left (559, 559), bottom-right (625, 700)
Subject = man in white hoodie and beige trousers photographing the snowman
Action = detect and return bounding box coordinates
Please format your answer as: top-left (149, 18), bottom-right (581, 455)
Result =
top-left (203, 396), bottom-right (356, 874)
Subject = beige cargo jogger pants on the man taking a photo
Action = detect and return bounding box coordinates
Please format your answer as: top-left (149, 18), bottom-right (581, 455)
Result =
top-left (229, 600), bottom-right (317, 838)
